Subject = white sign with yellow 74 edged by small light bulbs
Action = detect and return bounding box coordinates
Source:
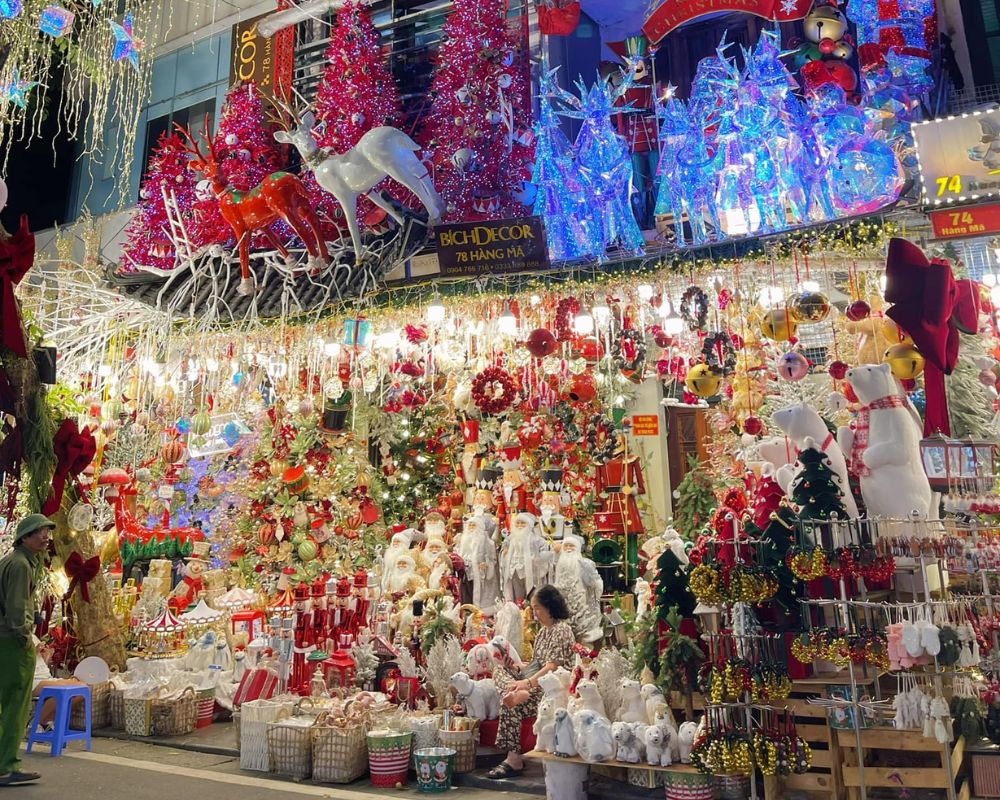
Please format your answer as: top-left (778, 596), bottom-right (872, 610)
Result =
top-left (912, 108), bottom-right (1000, 205)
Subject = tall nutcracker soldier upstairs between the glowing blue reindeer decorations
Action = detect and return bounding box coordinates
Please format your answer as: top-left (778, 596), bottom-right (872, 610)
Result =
top-left (607, 34), bottom-right (660, 230)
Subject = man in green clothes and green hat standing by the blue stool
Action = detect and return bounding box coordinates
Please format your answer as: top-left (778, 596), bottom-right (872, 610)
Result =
top-left (0, 514), bottom-right (55, 786)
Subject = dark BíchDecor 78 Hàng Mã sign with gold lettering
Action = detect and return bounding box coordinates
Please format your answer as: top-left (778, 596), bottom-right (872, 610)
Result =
top-left (435, 217), bottom-right (549, 276)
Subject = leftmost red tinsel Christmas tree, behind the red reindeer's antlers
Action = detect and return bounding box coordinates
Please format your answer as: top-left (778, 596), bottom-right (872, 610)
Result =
top-left (119, 133), bottom-right (196, 273)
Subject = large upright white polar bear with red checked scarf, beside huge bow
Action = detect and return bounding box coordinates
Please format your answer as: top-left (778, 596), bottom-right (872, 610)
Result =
top-left (837, 364), bottom-right (933, 519)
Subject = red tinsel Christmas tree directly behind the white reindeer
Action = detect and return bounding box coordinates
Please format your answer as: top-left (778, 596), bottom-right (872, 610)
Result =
top-left (303, 0), bottom-right (406, 233)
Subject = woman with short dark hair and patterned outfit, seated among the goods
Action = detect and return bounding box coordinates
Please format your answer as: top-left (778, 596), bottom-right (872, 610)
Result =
top-left (487, 586), bottom-right (575, 780)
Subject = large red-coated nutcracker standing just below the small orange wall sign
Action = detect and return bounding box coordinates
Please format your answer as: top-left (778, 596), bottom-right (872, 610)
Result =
top-left (594, 434), bottom-right (646, 585)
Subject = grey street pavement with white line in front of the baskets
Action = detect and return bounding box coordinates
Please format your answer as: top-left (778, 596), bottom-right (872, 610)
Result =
top-left (11, 738), bottom-right (538, 800)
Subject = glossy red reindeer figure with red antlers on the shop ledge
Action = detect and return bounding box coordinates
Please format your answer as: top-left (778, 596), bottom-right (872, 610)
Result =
top-left (176, 117), bottom-right (330, 295)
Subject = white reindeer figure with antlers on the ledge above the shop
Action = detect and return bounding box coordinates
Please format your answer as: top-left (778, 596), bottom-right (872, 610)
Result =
top-left (274, 106), bottom-right (444, 264)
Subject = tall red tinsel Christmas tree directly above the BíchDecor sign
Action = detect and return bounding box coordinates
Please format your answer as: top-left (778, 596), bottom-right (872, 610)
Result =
top-left (425, 0), bottom-right (534, 221)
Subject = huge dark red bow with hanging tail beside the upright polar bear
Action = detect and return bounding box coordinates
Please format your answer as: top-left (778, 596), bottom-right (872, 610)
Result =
top-left (885, 239), bottom-right (979, 436)
